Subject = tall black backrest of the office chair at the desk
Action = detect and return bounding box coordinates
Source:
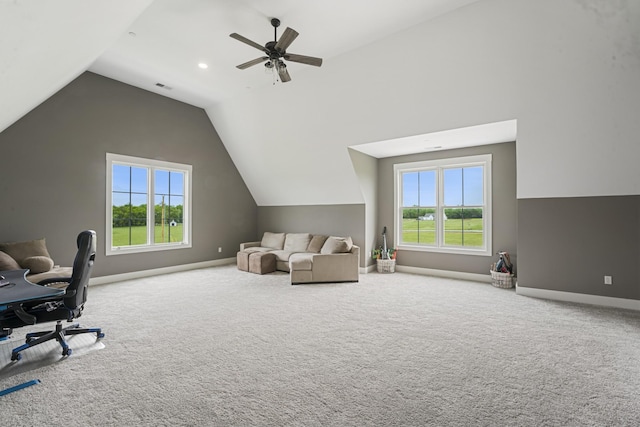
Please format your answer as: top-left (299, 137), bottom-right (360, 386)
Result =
top-left (64, 230), bottom-right (96, 318)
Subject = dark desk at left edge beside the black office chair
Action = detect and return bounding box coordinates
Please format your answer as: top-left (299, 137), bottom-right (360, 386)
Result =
top-left (0, 270), bottom-right (65, 337)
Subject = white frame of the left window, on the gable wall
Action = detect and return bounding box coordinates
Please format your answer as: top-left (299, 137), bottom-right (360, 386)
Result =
top-left (105, 153), bottom-right (193, 256)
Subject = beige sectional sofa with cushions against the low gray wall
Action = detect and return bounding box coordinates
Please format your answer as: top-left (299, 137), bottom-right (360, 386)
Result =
top-left (238, 232), bottom-right (360, 285)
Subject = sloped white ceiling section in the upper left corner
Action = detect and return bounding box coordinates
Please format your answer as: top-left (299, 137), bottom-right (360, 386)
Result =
top-left (0, 0), bottom-right (152, 132)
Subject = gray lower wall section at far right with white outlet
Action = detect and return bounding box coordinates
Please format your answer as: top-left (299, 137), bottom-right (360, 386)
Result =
top-left (518, 196), bottom-right (640, 299)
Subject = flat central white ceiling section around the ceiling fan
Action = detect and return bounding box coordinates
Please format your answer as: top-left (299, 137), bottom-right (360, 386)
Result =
top-left (89, 0), bottom-right (477, 108)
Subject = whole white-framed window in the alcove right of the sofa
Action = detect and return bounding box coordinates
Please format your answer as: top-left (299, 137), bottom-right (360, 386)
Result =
top-left (394, 154), bottom-right (491, 255)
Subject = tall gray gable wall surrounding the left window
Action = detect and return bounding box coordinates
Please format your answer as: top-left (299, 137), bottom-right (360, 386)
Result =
top-left (0, 72), bottom-right (257, 276)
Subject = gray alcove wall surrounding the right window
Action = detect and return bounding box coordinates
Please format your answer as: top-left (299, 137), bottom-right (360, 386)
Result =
top-left (378, 142), bottom-right (518, 275)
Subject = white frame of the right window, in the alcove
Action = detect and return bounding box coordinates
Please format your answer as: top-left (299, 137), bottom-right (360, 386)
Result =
top-left (393, 154), bottom-right (493, 256)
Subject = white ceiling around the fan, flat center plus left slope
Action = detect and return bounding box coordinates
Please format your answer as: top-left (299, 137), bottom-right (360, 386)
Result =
top-left (0, 0), bottom-right (477, 130)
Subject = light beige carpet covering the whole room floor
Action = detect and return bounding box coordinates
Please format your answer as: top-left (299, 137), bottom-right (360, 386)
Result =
top-left (0, 266), bottom-right (640, 426)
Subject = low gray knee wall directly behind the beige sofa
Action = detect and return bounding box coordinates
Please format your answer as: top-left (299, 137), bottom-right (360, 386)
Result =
top-left (252, 204), bottom-right (366, 267)
